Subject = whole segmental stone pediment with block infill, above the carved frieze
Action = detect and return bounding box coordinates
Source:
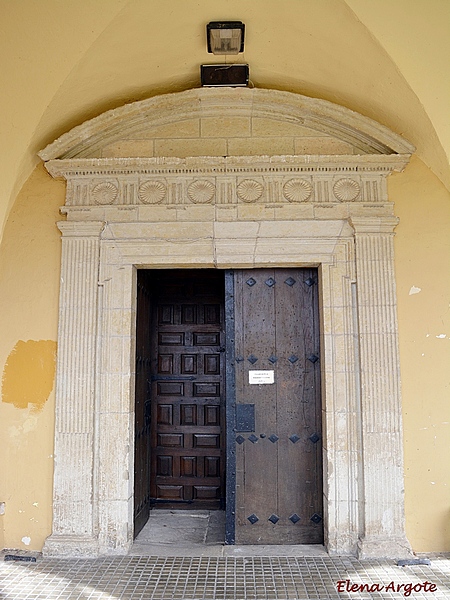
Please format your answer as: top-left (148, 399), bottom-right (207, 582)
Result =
top-left (39, 88), bottom-right (414, 161)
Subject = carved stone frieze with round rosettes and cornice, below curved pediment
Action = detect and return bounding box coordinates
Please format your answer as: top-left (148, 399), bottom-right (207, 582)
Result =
top-left (47, 155), bottom-right (407, 213)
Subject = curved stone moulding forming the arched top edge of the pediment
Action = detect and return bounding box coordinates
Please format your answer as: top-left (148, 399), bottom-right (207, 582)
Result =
top-left (39, 88), bottom-right (415, 161)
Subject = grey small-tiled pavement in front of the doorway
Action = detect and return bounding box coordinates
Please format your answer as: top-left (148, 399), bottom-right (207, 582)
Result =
top-left (0, 556), bottom-right (450, 600)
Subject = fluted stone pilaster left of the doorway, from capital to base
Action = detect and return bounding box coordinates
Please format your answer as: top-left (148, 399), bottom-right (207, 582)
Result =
top-left (44, 221), bottom-right (103, 556)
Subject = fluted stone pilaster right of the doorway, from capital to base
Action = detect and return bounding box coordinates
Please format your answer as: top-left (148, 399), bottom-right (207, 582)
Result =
top-left (351, 216), bottom-right (411, 558)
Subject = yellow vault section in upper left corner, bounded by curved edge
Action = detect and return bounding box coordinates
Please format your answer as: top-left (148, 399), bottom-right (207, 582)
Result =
top-left (0, 0), bottom-right (129, 244)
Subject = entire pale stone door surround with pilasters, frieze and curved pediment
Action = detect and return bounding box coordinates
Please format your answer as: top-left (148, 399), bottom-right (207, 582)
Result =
top-left (40, 88), bottom-right (413, 557)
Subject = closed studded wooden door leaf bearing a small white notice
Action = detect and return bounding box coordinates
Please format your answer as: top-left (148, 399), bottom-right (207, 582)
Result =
top-left (235, 269), bottom-right (323, 544)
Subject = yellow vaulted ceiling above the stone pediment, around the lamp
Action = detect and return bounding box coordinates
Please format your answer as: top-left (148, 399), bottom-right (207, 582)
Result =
top-left (0, 0), bottom-right (450, 239)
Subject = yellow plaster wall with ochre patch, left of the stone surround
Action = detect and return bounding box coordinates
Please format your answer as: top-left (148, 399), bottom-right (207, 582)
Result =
top-left (0, 166), bottom-right (64, 550)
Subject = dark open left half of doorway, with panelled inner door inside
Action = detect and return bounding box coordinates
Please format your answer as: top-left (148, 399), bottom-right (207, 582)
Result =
top-left (134, 269), bottom-right (225, 536)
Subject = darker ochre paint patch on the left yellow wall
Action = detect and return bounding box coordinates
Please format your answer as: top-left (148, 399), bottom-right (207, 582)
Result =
top-left (2, 340), bottom-right (56, 412)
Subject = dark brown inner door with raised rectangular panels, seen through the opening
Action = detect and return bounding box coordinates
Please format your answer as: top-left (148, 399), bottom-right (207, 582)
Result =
top-left (151, 270), bottom-right (225, 509)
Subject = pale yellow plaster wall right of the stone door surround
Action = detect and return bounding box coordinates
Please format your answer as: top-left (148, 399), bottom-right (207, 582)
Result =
top-left (389, 157), bottom-right (450, 552)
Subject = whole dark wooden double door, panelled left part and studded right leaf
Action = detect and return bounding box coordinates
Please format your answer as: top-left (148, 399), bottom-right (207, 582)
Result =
top-left (135, 269), bottom-right (323, 544)
